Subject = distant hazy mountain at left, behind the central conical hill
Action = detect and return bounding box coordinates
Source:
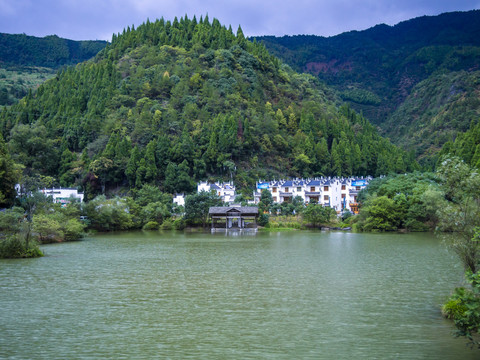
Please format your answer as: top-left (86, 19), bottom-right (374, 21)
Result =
top-left (0, 33), bottom-right (107, 106)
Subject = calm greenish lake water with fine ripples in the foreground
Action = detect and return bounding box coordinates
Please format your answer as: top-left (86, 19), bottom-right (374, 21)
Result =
top-left (0, 232), bottom-right (480, 359)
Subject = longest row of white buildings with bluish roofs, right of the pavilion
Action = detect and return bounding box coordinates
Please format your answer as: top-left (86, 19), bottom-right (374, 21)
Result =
top-left (253, 177), bottom-right (372, 213)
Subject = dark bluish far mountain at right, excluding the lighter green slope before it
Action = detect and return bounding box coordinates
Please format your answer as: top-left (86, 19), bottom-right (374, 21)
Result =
top-left (257, 10), bottom-right (480, 163)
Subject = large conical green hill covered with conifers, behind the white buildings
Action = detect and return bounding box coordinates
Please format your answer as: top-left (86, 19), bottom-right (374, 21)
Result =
top-left (0, 17), bottom-right (416, 202)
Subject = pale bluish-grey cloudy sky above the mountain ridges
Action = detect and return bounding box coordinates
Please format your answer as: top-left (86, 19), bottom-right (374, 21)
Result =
top-left (0, 0), bottom-right (480, 40)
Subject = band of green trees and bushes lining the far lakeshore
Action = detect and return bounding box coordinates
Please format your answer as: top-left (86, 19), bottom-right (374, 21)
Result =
top-left (0, 157), bottom-right (480, 249)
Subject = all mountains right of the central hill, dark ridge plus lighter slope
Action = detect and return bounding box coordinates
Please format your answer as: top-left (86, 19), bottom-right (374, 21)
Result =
top-left (257, 10), bottom-right (480, 165)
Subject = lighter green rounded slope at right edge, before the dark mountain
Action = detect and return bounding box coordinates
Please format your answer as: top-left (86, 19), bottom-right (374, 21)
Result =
top-left (383, 71), bottom-right (480, 161)
